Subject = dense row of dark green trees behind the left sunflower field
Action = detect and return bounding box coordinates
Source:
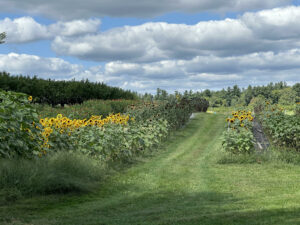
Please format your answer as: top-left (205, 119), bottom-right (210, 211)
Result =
top-left (0, 72), bottom-right (136, 106)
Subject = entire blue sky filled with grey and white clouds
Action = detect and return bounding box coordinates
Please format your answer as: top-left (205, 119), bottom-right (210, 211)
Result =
top-left (0, 0), bottom-right (300, 93)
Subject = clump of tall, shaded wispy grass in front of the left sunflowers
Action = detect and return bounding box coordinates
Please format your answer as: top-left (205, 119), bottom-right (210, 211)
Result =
top-left (0, 152), bottom-right (104, 200)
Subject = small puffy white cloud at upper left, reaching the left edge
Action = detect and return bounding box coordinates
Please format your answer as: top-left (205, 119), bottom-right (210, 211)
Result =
top-left (0, 17), bottom-right (100, 43)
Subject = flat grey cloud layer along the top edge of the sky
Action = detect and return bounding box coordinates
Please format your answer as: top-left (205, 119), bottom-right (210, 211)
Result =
top-left (0, 0), bottom-right (291, 19)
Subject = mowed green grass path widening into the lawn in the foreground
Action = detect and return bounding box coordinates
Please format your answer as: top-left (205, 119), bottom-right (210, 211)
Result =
top-left (0, 114), bottom-right (300, 225)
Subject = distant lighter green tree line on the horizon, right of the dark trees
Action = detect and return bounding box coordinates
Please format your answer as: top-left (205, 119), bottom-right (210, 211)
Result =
top-left (140, 82), bottom-right (300, 107)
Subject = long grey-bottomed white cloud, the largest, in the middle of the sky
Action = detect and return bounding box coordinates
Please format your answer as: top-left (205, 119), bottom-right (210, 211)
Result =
top-left (52, 19), bottom-right (255, 62)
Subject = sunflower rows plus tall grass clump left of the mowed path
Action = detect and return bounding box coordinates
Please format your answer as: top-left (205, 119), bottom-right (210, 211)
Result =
top-left (0, 90), bottom-right (208, 200)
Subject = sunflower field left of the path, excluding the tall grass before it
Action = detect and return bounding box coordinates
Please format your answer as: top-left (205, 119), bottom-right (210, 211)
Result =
top-left (0, 88), bottom-right (207, 161)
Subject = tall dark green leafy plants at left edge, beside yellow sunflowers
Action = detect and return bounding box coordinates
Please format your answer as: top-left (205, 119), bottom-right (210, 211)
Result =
top-left (0, 89), bottom-right (42, 158)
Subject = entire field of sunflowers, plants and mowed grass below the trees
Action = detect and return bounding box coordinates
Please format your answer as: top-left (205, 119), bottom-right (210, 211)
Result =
top-left (0, 87), bottom-right (300, 224)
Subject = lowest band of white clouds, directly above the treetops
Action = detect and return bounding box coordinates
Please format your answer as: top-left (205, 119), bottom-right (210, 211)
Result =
top-left (0, 49), bottom-right (300, 92)
